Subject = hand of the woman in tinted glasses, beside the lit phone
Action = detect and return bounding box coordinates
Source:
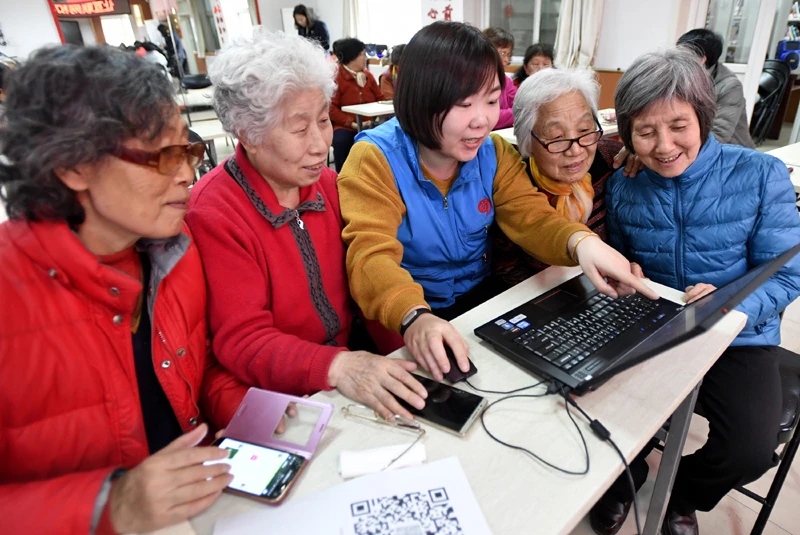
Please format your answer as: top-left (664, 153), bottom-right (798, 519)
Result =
top-left (109, 424), bottom-right (233, 533)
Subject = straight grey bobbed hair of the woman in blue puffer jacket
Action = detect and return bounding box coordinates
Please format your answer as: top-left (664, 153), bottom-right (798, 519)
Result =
top-left (614, 46), bottom-right (717, 152)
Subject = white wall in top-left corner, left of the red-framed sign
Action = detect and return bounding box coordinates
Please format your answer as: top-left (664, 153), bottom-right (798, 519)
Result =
top-left (0, 0), bottom-right (61, 59)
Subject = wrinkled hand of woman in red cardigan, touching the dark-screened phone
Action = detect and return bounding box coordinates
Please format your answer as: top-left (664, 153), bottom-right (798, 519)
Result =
top-left (328, 352), bottom-right (428, 420)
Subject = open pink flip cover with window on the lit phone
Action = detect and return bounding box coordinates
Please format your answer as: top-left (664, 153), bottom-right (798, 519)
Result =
top-left (223, 387), bottom-right (333, 460)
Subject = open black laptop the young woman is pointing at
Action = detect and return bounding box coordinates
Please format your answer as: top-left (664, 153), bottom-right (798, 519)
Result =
top-left (475, 244), bottom-right (800, 395)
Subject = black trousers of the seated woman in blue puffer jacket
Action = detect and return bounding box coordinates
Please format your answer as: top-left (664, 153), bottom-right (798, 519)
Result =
top-left (607, 347), bottom-right (783, 514)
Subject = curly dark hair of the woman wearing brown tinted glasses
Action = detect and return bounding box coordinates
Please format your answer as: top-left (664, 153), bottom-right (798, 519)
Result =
top-left (0, 45), bottom-right (178, 227)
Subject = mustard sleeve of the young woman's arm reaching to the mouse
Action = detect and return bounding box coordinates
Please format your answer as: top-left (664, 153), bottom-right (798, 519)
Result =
top-left (337, 141), bottom-right (427, 332)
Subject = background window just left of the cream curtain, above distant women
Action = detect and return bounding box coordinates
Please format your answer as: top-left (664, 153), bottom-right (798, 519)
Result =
top-left (488, 0), bottom-right (561, 56)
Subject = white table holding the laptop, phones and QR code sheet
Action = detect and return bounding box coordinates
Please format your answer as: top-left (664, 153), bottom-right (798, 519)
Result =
top-left (180, 267), bottom-right (746, 535)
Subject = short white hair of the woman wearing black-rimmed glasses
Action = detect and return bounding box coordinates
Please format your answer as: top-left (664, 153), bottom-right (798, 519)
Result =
top-left (514, 69), bottom-right (600, 158)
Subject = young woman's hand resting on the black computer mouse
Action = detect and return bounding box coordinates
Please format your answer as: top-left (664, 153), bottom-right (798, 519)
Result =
top-left (403, 314), bottom-right (469, 382)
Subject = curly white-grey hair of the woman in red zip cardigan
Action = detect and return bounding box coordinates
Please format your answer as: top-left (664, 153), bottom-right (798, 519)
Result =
top-left (209, 26), bottom-right (336, 145)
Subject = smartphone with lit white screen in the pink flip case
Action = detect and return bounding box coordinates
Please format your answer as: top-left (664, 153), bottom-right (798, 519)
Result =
top-left (205, 437), bottom-right (306, 505)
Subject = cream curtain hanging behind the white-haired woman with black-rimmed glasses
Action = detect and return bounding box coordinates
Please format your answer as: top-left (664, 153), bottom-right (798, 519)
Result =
top-left (555, 0), bottom-right (605, 68)
